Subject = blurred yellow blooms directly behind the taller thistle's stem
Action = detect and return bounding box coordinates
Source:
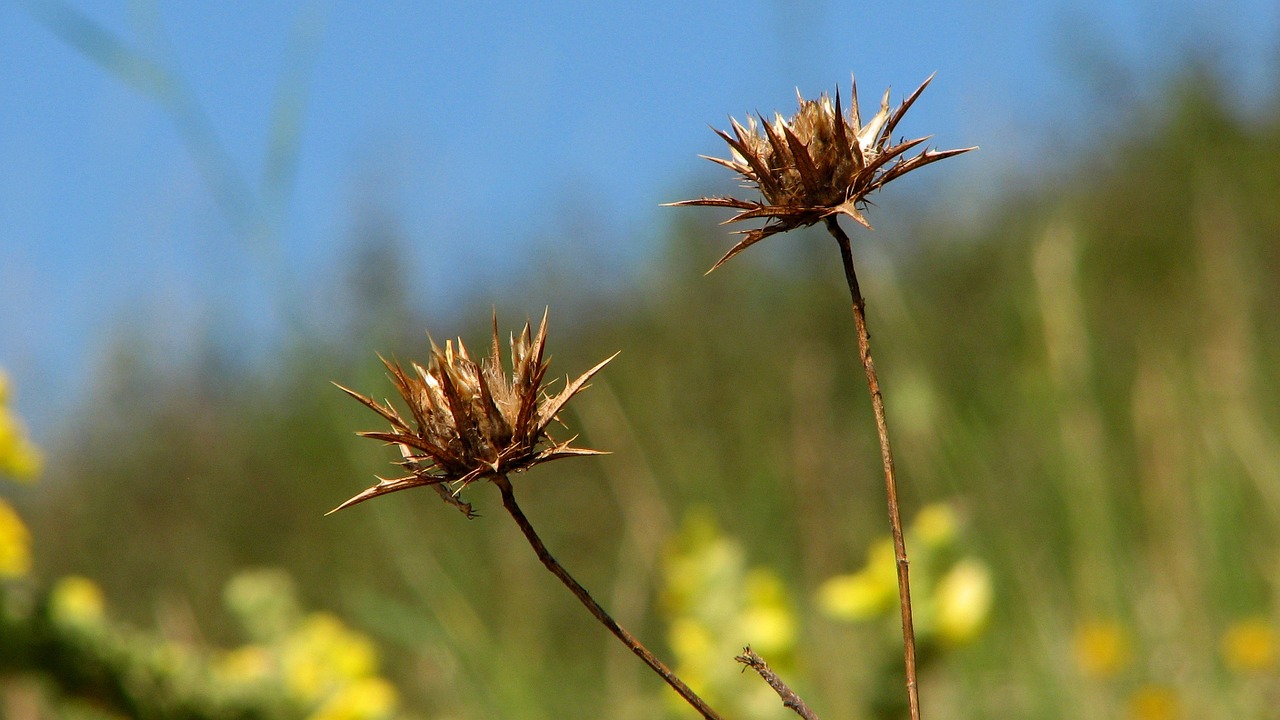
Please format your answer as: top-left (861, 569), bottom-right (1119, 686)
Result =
top-left (818, 503), bottom-right (993, 646)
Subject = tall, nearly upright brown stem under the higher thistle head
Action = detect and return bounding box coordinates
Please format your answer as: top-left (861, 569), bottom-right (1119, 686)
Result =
top-left (827, 217), bottom-right (920, 720)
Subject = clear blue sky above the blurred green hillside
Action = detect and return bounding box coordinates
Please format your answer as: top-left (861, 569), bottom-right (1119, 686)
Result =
top-left (0, 0), bottom-right (1280, 432)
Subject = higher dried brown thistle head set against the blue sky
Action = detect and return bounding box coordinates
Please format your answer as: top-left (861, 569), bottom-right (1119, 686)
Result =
top-left (669, 76), bottom-right (974, 270)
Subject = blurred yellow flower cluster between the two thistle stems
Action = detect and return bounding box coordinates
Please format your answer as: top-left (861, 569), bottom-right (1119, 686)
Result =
top-left (662, 511), bottom-right (796, 719)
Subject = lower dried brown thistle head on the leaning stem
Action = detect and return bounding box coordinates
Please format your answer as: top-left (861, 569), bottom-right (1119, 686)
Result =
top-left (332, 314), bottom-right (617, 515)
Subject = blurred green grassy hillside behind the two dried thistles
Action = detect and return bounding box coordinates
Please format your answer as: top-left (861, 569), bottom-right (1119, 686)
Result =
top-left (15, 68), bottom-right (1280, 720)
